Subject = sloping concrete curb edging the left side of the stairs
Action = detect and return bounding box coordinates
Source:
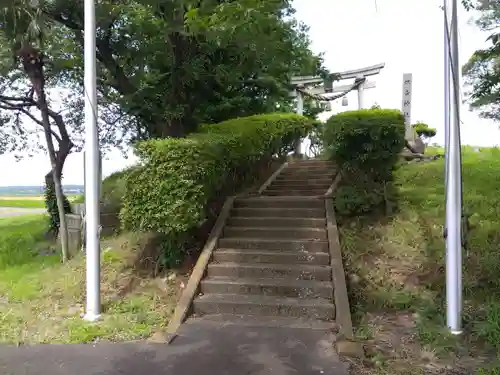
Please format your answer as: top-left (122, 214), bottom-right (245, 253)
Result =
top-left (148, 196), bottom-right (236, 344)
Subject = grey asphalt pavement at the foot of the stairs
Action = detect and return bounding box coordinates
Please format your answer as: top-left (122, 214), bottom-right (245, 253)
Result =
top-left (0, 324), bottom-right (347, 375)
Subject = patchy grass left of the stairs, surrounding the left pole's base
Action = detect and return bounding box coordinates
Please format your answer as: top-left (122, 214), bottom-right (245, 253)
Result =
top-left (0, 216), bottom-right (179, 344)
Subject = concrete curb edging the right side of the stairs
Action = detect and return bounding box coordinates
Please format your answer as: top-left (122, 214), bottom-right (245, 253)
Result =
top-left (325, 184), bottom-right (364, 358)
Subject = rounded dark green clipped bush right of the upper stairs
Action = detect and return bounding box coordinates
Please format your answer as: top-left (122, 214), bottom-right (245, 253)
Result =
top-left (323, 108), bottom-right (405, 216)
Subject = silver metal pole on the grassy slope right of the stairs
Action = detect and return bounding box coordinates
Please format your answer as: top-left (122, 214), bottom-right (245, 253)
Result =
top-left (445, 0), bottom-right (462, 335)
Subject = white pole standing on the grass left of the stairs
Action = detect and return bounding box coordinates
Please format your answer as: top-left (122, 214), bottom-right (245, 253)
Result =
top-left (84, 0), bottom-right (101, 321)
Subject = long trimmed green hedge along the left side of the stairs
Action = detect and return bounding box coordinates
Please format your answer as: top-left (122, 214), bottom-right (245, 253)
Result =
top-left (121, 113), bottom-right (315, 239)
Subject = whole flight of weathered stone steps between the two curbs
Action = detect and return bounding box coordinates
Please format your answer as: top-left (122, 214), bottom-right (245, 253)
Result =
top-left (189, 160), bottom-right (335, 326)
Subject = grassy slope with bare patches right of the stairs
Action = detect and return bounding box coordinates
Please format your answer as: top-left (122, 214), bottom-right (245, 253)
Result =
top-left (341, 149), bottom-right (500, 375)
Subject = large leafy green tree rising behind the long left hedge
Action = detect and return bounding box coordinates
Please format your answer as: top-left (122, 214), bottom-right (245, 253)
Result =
top-left (33, 0), bottom-right (321, 138)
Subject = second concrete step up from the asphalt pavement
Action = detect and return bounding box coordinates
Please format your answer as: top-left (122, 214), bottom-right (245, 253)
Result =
top-left (201, 277), bottom-right (333, 301)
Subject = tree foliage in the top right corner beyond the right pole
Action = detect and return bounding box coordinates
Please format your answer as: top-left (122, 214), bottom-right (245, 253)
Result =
top-left (463, 0), bottom-right (500, 120)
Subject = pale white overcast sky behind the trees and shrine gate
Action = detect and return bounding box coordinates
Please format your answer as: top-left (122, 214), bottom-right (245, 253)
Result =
top-left (0, 0), bottom-right (500, 186)
